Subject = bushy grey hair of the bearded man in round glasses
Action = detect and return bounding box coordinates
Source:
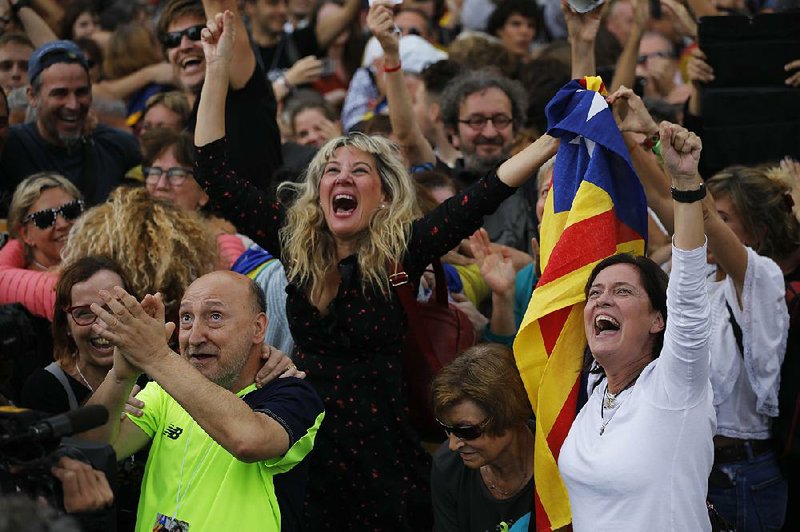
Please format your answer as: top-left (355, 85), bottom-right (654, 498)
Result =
top-left (439, 70), bottom-right (528, 131)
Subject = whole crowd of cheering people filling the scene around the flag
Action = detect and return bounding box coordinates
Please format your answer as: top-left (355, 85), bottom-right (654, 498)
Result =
top-left (0, 0), bottom-right (800, 532)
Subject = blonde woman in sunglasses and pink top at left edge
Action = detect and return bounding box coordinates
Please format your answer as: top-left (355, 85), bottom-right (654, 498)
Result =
top-left (0, 172), bottom-right (84, 319)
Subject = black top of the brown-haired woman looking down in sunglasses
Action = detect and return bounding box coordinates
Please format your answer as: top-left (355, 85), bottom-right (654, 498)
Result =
top-left (431, 442), bottom-right (535, 532)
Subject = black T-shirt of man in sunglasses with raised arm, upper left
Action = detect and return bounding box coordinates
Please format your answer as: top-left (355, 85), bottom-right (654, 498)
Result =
top-left (186, 65), bottom-right (283, 190)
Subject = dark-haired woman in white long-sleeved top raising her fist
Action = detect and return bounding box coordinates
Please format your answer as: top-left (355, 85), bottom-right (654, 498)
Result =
top-left (558, 123), bottom-right (714, 532)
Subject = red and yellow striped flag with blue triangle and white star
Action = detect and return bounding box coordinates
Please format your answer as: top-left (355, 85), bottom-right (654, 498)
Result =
top-left (514, 77), bottom-right (647, 531)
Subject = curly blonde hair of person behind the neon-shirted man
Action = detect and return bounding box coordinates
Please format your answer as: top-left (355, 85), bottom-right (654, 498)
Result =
top-left (62, 187), bottom-right (217, 316)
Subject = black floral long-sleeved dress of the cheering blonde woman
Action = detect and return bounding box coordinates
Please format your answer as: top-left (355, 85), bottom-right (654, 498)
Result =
top-left (196, 140), bottom-right (515, 531)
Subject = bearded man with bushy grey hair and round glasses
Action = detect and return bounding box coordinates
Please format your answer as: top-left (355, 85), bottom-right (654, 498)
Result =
top-left (439, 70), bottom-right (534, 251)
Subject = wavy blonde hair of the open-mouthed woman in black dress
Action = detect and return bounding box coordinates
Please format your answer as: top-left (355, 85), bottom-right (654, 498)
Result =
top-left (279, 133), bottom-right (420, 301)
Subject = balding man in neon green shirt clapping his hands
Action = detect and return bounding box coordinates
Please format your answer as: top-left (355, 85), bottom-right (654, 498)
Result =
top-left (79, 271), bottom-right (324, 532)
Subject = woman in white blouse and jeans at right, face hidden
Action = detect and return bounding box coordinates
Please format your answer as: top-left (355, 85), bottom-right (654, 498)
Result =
top-left (705, 166), bottom-right (800, 532)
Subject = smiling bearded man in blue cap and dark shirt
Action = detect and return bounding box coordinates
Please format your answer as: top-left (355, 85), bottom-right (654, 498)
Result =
top-left (0, 41), bottom-right (141, 218)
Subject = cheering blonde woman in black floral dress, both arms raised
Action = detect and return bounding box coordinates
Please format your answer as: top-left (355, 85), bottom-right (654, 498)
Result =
top-left (195, 12), bottom-right (557, 530)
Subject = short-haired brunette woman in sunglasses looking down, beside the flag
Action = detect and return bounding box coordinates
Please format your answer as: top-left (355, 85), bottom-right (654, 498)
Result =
top-left (431, 344), bottom-right (534, 531)
